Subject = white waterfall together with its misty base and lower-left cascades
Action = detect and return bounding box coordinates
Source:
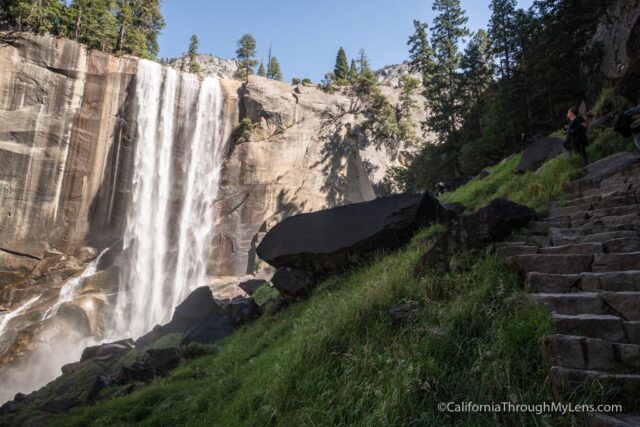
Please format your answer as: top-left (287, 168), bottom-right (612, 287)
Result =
top-left (0, 60), bottom-right (225, 402)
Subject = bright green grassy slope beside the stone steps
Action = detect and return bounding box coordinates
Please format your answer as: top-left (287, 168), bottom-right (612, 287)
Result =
top-left (51, 131), bottom-right (636, 426)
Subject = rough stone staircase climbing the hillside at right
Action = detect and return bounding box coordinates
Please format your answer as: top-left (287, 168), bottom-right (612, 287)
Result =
top-left (496, 162), bottom-right (640, 427)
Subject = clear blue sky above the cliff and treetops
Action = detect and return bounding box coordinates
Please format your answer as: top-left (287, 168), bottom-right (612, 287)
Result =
top-left (159, 0), bottom-right (533, 81)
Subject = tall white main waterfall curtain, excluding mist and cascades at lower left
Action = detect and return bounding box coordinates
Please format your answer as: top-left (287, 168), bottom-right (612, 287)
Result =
top-left (111, 60), bottom-right (223, 337)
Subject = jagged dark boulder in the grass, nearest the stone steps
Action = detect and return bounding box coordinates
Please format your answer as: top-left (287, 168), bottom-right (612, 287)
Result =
top-left (415, 199), bottom-right (537, 277)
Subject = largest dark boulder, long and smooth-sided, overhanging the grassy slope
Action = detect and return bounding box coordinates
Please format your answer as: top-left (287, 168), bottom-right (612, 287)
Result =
top-left (257, 193), bottom-right (452, 276)
